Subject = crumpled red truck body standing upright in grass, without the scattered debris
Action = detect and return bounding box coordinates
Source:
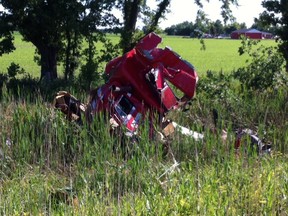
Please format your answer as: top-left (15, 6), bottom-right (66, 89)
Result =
top-left (90, 33), bottom-right (198, 132)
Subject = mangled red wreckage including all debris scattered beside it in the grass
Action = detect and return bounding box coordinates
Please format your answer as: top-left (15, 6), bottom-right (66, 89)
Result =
top-left (54, 33), bottom-right (270, 155)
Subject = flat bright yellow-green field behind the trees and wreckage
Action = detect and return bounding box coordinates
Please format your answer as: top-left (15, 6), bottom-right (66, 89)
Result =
top-left (0, 33), bottom-right (275, 77)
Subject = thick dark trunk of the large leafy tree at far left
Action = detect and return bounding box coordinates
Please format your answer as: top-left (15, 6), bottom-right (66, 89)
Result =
top-left (40, 47), bottom-right (57, 81)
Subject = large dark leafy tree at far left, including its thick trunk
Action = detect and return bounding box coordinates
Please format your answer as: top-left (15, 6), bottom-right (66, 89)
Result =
top-left (0, 0), bottom-right (114, 80)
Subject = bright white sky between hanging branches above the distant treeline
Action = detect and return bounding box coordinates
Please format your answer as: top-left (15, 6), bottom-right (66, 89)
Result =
top-left (147, 0), bottom-right (264, 29)
